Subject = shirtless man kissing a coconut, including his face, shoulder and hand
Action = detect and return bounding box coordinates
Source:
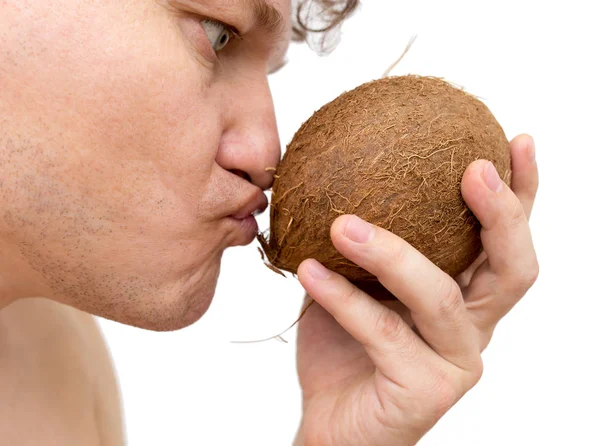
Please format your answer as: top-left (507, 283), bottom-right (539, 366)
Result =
top-left (0, 0), bottom-right (537, 446)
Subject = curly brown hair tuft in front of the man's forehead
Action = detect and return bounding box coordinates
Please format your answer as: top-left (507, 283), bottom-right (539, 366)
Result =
top-left (292, 0), bottom-right (359, 53)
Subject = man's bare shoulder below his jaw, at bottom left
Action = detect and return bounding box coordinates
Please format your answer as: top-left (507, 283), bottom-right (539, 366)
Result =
top-left (0, 299), bottom-right (124, 446)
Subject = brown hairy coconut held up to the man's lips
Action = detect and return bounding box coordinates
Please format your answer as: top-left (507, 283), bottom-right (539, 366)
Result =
top-left (259, 75), bottom-right (510, 284)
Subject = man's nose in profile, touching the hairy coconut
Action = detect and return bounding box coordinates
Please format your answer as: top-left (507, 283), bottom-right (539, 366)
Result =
top-left (216, 77), bottom-right (281, 190)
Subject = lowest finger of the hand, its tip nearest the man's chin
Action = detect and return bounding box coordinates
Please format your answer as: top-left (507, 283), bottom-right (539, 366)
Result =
top-left (298, 259), bottom-right (440, 380)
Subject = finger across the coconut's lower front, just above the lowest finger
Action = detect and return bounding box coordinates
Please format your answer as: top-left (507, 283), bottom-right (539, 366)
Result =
top-left (331, 215), bottom-right (479, 368)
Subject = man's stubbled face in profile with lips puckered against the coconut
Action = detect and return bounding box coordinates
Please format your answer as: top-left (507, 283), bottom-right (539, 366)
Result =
top-left (0, 0), bottom-right (290, 330)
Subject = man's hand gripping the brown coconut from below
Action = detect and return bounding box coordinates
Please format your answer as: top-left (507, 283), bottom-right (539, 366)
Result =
top-left (296, 135), bottom-right (538, 446)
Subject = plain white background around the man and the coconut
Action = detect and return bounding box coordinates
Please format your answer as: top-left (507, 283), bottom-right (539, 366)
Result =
top-left (101, 0), bottom-right (600, 446)
